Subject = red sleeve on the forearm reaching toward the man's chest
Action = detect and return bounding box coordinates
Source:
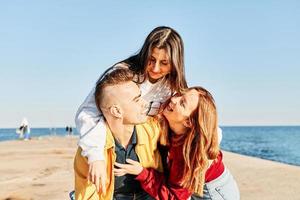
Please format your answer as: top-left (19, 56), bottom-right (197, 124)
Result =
top-left (136, 168), bottom-right (191, 200)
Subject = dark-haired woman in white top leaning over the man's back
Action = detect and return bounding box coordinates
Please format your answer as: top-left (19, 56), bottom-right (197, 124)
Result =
top-left (75, 26), bottom-right (187, 193)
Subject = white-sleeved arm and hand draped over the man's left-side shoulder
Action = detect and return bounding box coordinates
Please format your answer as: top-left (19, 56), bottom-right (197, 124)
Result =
top-left (75, 63), bottom-right (128, 192)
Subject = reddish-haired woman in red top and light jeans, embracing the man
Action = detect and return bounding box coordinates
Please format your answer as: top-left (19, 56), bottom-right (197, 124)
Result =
top-left (114, 87), bottom-right (239, 200)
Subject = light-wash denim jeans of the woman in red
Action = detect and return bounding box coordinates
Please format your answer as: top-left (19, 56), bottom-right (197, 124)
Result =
top-left (191, 168), bottom-right (240, 200)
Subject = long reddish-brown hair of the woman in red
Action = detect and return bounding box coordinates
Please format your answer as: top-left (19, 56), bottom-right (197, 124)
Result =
top-left (181, 87), bottom-right (219, 196)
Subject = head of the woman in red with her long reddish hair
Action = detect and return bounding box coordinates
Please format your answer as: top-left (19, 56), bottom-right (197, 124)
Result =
top-left (163, 87), bottom-right (220, 194)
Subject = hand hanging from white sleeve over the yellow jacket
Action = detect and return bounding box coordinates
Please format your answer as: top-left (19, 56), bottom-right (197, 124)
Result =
top-left (88, 160), bottom-right (106, 195)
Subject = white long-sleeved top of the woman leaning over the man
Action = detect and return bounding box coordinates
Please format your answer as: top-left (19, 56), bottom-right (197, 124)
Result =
top-left (75, 64), bottom-right (171, 163)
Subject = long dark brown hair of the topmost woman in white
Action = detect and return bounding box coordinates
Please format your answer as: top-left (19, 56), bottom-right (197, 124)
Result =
top-left (121, 26), bottom-right (187, 93)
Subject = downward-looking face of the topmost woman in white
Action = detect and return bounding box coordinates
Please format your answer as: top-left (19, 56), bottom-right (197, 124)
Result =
top-left (147, 48), bottom-right (172, 83)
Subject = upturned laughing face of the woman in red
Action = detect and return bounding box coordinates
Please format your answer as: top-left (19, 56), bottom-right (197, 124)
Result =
top-left (163, 89), bottom-right (199, 130)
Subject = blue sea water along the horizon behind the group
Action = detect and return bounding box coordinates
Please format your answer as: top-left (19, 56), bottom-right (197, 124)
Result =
top-left (0, 126), bottom-right (300, 166)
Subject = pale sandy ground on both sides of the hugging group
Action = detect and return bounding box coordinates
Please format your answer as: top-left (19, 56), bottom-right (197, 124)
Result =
top-left (0, 137), bottom-right (300, 200)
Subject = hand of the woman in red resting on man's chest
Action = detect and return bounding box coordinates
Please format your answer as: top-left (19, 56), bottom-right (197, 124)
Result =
top-left (114, 159), bottom-right (143, 176)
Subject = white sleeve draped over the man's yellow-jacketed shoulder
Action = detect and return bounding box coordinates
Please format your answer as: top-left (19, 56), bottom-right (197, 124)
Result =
top-left (75, 89), bottom-right (106, 163)
